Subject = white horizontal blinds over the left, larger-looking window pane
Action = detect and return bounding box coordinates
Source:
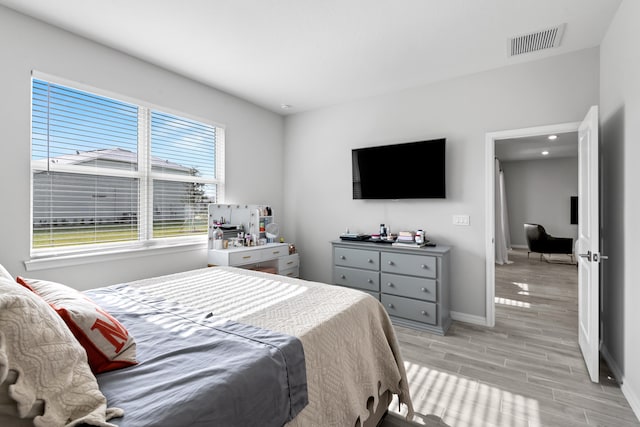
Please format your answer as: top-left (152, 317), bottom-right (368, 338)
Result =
top-left (31, 79), bottom-right (139, 248)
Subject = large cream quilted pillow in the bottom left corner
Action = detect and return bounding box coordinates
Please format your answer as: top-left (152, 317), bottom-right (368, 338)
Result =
top-left (0, 277), bottom-right (123, 427)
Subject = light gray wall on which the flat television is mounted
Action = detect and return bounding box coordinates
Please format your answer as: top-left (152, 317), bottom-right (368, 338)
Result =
top-left (284, 48), bottom-right (599, 318)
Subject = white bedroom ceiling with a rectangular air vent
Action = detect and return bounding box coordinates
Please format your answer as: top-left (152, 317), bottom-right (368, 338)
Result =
top-left (0, 0), bottom-right (621, 114)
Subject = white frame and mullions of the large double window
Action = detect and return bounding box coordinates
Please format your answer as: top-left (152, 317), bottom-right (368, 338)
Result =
top-left (25, 71), bottom-right (226, 262)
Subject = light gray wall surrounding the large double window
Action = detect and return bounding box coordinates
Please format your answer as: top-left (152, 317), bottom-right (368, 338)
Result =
top-left (0, 6), bottom-right (284, 289)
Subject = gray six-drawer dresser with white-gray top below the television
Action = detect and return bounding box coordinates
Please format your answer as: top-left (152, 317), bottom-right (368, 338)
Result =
top-left (331, 240), bottom-right (451, 335)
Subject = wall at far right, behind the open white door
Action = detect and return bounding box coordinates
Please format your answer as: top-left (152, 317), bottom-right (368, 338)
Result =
top-left (600, 0), bottom-right (640, 418)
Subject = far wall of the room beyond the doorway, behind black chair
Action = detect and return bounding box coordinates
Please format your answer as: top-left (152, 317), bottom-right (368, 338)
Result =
top-left (501, 157), bottom-right (578, 246)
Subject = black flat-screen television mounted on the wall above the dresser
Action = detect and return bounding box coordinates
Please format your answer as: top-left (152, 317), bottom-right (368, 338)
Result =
top-left (351, 138), bottom-right (446, 199)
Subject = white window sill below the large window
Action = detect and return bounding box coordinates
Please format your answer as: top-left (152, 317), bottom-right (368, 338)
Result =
top-left (24, 236), bottom-right (207, 271)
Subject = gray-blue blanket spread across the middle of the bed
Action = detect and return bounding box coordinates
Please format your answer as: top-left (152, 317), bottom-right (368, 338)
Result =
top-left (85, 285), bottom-right (307, 427)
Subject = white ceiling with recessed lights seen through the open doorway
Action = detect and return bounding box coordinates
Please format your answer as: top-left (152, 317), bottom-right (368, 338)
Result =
top-left (495, 132), bottom-right (578, 162)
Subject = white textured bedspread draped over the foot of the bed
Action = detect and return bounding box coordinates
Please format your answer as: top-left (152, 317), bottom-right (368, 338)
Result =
top-left (124, 267), bottom-right (413, 427)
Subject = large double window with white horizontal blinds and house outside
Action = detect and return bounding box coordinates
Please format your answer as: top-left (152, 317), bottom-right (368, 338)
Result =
top-left (31, 78), bottom-right (224, 253)
